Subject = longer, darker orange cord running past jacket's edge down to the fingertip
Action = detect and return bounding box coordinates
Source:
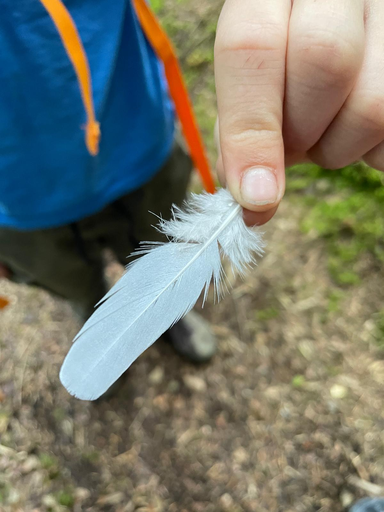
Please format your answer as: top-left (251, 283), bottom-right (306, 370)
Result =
top-left (133, 0), bottom-right (215, 194)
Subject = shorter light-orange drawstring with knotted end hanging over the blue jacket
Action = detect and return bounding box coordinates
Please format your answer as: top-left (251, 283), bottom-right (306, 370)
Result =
top-left (40, 0), bottom-right (100, 156)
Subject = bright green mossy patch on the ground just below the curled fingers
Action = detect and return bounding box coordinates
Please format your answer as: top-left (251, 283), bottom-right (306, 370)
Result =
top-left (287, 164), bottom-right (384, 286)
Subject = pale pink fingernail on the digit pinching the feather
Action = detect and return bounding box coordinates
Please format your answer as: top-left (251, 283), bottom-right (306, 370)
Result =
top-left (241, 167), bottom-right (278, 206)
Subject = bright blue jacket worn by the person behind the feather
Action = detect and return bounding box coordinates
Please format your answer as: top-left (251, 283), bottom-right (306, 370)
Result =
top-left (0, 0), bottom-right (174, 230)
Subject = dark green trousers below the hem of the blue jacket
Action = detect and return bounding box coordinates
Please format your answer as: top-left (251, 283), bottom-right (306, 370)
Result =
top-left (0, 138), bottom-right (192, 318)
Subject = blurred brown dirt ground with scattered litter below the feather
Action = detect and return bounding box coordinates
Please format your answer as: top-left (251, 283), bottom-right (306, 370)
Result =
top-left (0, 201), bottom-right (384, 512)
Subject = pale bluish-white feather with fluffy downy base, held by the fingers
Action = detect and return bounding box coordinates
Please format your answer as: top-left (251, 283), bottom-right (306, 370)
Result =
top-left (60, 189), bottom-right (263, 400)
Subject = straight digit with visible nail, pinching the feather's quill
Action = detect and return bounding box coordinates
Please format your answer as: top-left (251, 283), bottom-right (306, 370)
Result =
top-left (215, 0), bottom-right (291, 222)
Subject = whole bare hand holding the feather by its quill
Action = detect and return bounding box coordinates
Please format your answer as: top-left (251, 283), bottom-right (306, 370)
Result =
top-left (215, 0), bottom-right (384, 224)
